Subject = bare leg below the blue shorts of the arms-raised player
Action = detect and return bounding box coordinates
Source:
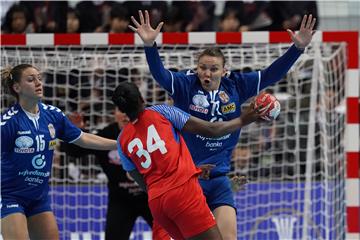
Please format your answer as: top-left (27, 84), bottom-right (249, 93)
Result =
top-left (214, 206), bottom-right (237, 240)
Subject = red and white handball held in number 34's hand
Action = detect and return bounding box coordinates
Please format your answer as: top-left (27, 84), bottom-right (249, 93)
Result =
top-left (254, 92), bottom-right (280, 121)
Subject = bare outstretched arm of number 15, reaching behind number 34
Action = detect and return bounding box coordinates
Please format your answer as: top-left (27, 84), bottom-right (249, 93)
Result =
top-left (73, 133), bottom-right (117, 150)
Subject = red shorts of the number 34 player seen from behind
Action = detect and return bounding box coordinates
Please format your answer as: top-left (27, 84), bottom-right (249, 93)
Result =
top-left (149, 176), bottom-right (216, 240)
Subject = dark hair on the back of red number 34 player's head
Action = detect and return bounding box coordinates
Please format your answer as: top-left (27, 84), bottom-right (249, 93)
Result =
top-left (111, 82), bottom-right (144, 121)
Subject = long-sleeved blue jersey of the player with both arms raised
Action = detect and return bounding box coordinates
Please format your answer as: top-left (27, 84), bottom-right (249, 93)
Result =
top-left (145, 45), bottom-right (302, 176)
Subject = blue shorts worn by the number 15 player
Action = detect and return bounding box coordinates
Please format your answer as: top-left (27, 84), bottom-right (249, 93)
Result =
top-left (1, 196), bottom-right (51, 218)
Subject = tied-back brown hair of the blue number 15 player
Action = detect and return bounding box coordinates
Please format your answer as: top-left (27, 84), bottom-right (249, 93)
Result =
top-left (1, 64), bottom-right (37, 100)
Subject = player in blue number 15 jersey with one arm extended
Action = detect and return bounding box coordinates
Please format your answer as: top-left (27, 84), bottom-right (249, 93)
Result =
top-left (0, 64), bottom-right (117, 240)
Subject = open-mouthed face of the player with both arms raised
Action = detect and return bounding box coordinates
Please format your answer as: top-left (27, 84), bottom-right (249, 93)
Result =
top-left (196, 55), bottom-right (225, 92)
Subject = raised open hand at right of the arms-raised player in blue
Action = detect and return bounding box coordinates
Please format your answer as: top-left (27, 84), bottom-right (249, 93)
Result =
top-left (286, 14), bottom-right (316, 49)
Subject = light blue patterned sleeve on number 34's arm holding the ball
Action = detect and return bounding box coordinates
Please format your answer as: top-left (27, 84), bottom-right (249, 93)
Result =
top-left (149, 105), bottom-right (190, 130)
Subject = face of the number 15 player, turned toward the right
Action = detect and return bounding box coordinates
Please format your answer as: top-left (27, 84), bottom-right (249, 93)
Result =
top-left (14, 68), bottom-right (43, 100)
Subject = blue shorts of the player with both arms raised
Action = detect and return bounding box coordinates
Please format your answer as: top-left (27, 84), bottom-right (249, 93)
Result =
top-left (199, 175), bottom-right (236, 211)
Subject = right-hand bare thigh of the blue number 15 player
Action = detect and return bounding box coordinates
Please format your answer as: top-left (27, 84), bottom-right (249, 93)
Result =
top-left (28, 212), bottom-right (59, 240)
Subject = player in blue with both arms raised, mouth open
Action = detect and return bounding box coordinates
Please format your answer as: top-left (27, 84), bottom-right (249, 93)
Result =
top-left (129, 11), bottom-right (316, 239)
